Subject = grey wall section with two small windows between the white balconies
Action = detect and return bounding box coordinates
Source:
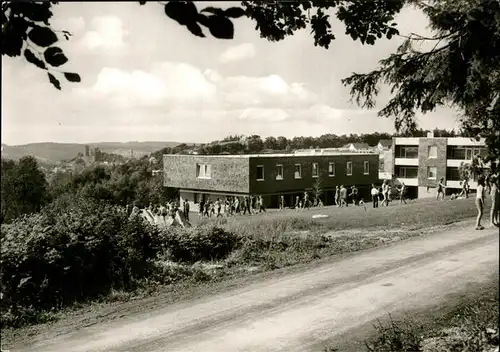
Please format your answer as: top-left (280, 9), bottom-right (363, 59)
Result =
top-left (418, 138), bottom-right (447, 187)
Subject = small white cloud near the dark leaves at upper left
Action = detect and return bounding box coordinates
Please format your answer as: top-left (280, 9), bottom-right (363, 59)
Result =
top-left (82, 16), bottom-right (128, 49)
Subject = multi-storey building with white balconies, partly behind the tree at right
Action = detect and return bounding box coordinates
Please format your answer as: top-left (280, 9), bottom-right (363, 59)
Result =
top-left (392, 133), bottom-right (487, 198)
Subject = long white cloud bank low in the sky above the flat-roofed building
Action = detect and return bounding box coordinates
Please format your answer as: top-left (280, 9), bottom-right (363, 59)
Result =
top-left (85, 62), bottom-right (317, 110)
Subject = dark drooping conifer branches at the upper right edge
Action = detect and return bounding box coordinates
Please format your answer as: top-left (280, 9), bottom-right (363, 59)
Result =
top-left (342, 0), bottom-right (500, 168)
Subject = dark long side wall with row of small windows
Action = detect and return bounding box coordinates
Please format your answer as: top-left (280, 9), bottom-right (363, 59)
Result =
top-left (250, 154), bottom-right (379, 194)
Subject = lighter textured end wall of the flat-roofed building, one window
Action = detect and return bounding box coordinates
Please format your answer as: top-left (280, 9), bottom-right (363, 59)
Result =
top-left (163, 154), bottom-right (250, 193)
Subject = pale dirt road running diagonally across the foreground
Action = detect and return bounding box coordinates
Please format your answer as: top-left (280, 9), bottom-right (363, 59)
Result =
top-left (11, 229), bottom-right (499, 352)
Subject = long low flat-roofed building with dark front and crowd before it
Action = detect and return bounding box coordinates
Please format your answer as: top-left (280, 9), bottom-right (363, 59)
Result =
top-left (163, 149), bottom-right (379, 209)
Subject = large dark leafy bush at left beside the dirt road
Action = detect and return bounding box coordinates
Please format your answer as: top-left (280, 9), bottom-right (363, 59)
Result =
top-left (0, 199), bottom-right (158, 323)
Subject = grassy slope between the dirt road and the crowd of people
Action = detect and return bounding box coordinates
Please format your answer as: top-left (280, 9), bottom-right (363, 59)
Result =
top-left (2, 199), bottom-right (486, 348)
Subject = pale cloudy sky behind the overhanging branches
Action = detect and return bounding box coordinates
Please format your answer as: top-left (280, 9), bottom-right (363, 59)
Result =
top-left (2, 2), bottom-right (457, 145)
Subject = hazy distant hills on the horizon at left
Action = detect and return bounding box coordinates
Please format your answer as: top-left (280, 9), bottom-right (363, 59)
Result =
top-left (2, 141), bottom-right (180, 164)
